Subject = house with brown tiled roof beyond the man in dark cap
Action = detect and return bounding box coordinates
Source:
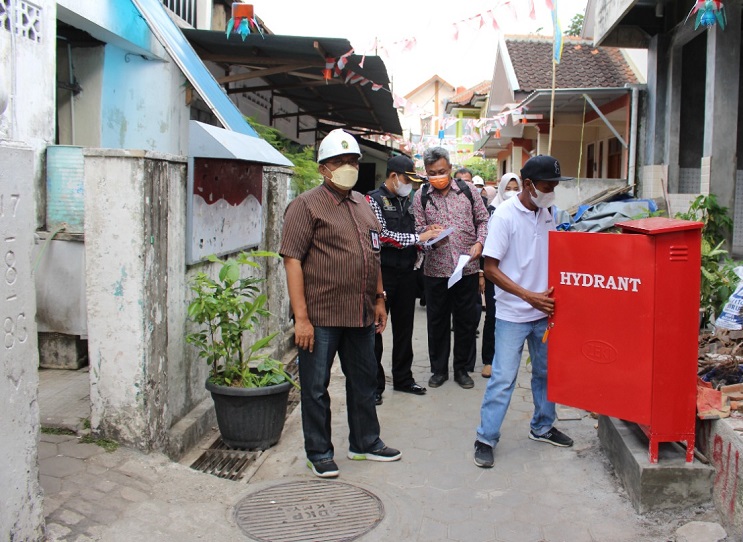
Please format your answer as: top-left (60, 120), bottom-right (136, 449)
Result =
top-left (477, 36), bottom-right (644, 209)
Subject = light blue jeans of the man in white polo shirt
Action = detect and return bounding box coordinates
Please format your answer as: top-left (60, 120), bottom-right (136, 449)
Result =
top-left (477, 318), bottom-right (555, 447)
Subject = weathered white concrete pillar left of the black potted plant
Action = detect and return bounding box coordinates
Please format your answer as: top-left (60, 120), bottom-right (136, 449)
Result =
top-left (85, 149), bottom-right (184, 451)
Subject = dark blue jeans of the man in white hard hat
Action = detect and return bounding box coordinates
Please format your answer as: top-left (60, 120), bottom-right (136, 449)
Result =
top-left (299, 325), bottom-right (384, 461)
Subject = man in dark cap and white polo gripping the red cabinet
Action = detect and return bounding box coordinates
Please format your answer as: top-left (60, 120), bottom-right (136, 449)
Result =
top-left (475, 154), bottom-right (573, 468)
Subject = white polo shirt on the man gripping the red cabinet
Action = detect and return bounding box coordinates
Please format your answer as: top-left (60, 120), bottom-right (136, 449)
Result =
top-left (482, 197), bottom-right (555, 323)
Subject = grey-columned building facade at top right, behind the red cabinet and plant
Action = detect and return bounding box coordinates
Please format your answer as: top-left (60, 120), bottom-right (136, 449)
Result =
top-left (584, 0), bottom-right (743, 256)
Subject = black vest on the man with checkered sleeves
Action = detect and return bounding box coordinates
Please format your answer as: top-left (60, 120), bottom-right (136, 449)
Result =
top-left (369, 184), bottom-right (418, 269)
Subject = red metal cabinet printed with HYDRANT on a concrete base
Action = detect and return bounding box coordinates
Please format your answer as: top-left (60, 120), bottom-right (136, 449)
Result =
top-left (547, 218), bottom-right (702, 463)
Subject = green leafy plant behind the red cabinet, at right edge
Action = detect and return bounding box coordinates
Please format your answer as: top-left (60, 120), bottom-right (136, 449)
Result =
top-left (676, 194), bottom-right (738, 327)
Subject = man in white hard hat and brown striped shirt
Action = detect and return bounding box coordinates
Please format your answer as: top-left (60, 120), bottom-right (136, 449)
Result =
top-left (279, 129), bottom-right (402, 478)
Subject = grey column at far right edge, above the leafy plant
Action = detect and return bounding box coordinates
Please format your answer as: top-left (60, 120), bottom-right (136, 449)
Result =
top-left (704, 2), bottom-right (741, 212)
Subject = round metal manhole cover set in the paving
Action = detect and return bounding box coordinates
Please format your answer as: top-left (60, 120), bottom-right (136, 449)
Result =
top-left (235, 481), bottom-right (384, 542)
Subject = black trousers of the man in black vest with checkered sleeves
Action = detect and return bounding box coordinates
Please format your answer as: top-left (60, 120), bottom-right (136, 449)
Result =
top-left (374, 266), bottom-right (417, 393)
